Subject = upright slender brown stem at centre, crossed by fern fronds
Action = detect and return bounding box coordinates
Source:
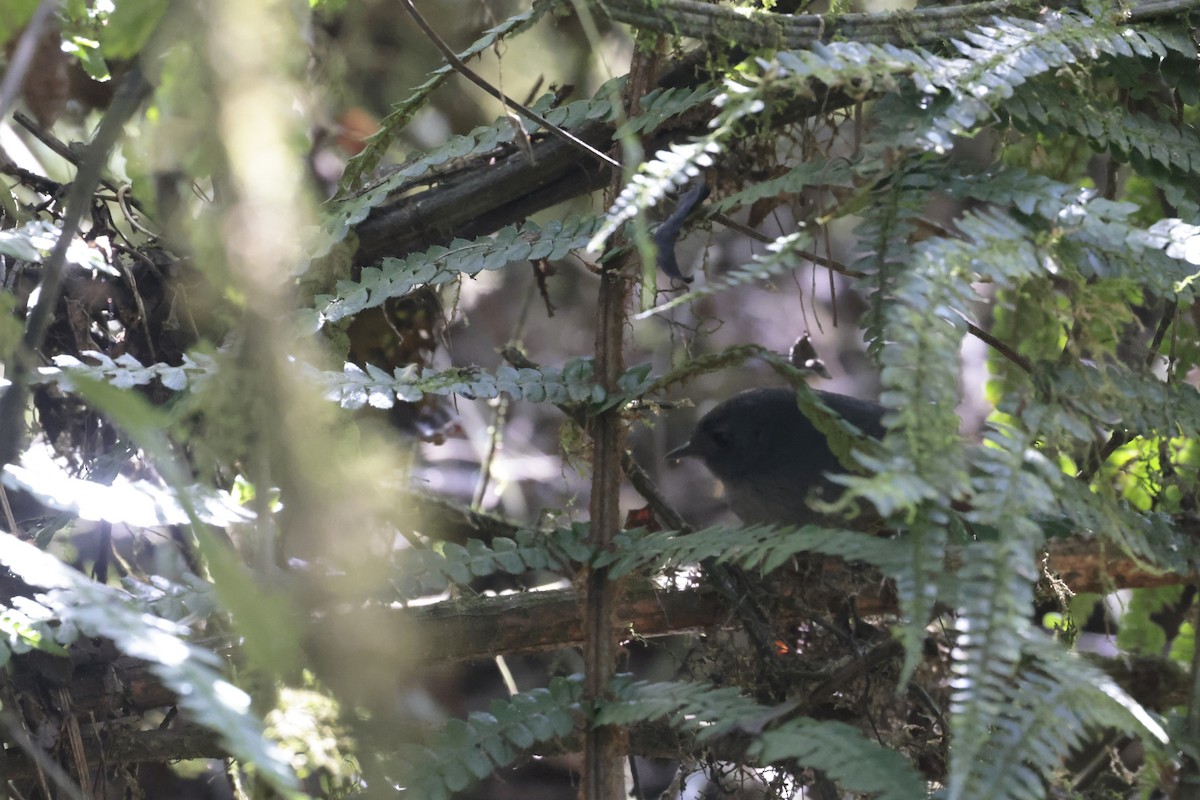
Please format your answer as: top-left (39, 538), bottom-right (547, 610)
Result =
top-left (580, 37), bottom-right (659, 800)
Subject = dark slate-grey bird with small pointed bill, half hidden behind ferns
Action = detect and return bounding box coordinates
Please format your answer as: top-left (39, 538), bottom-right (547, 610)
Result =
top-left (667, 389), bottom-right (887, 525)
